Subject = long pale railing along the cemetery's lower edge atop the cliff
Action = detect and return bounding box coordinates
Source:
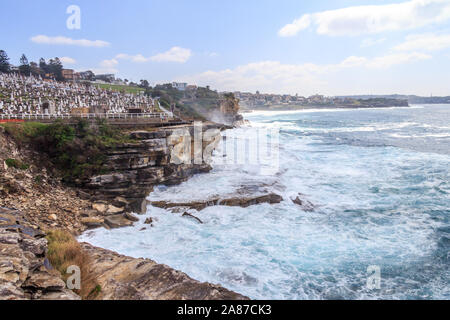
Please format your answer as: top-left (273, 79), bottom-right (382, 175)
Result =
top-left (0, 112), bottom-right (173, 120)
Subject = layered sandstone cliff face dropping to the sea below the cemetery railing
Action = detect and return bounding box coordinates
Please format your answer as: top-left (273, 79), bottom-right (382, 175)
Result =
top-left (83, 126), bottom-right (220, 213)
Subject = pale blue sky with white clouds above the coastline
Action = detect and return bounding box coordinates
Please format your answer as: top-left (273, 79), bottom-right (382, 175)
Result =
top-left (0, 0), bottom-right (450, 96)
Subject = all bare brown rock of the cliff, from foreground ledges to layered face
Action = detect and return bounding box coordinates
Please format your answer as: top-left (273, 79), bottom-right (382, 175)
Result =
top-left (0, 124), bottom-right (250, 300)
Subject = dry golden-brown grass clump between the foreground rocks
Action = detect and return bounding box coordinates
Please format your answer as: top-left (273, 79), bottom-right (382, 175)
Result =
top-left (47, 230), bottom-right (101, 299)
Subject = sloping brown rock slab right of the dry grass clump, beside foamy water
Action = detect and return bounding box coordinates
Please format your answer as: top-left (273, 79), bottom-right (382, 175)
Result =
top-left (82, 243), bottom-right (248, 300)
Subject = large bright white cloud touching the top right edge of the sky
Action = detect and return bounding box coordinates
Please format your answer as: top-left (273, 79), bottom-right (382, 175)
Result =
top-left (278, 0), bottom-right (450, 37)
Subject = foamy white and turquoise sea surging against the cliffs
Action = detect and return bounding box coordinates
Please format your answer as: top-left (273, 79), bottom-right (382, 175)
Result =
top-left (80, 105), bottom-right (450, 299)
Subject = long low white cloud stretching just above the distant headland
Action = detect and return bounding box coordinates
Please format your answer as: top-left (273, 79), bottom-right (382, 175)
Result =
top-left (177, 52), bottom-right (431, 94)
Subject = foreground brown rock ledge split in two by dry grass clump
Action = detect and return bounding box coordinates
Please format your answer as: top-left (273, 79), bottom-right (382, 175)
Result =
top-left (0, 208), bottom-right (248, 300)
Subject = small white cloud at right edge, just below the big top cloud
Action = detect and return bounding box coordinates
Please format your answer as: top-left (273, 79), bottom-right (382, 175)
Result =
top-left (394, 33), bottom-right (450, 51)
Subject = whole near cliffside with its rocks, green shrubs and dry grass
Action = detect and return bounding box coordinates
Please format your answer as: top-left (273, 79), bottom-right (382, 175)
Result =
top-left (0, 122), bottom-right (245, 300)
